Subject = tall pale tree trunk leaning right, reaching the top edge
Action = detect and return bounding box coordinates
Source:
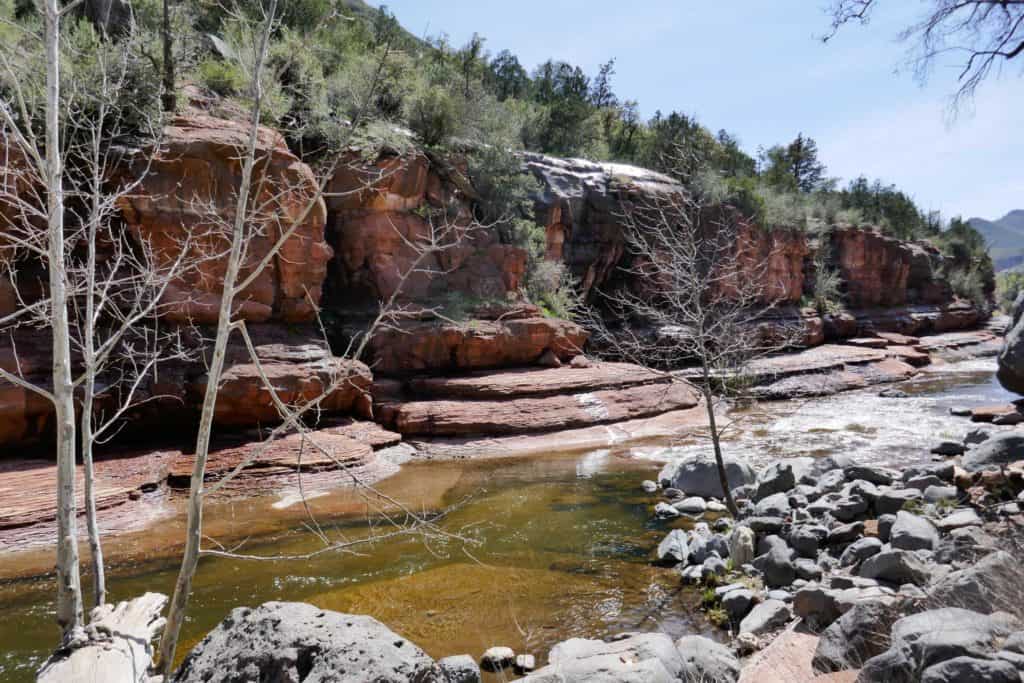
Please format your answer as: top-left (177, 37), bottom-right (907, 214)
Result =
top-left (160, 0), bottom-right (278, 677)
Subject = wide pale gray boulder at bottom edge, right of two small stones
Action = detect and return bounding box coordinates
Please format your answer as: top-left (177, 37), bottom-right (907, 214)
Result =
top-left (522, 633), bottom-right (683, 683)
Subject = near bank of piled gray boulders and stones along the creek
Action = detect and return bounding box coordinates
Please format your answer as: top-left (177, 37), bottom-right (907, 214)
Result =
top-left (151, 397), bottom-right (1024, 683)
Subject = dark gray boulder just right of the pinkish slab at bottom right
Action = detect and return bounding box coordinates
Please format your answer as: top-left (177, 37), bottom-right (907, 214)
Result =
top-left (812, 602), bottom-right (899, 673)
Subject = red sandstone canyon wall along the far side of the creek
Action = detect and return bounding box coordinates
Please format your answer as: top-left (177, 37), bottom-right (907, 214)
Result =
top-left (0, 118), bottom-right (982, 446)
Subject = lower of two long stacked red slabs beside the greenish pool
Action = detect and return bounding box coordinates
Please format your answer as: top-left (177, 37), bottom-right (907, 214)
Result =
top-left (390, 382), bottom-right (698, 436)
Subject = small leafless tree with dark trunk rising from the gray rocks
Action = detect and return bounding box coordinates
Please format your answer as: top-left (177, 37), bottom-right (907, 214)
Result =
top-left (590, 166), bottom-right (802, 516)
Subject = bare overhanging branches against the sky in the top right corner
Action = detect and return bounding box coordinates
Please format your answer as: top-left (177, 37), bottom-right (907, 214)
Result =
top-left (823, 0), bottom-right (1024, 108)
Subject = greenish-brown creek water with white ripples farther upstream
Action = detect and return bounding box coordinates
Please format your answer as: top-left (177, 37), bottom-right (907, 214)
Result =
top-left (0, 360), bottom-right (1015, 682)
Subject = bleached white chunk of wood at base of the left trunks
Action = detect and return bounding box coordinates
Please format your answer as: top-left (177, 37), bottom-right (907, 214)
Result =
top-left (36, 593), bottom-right (167, 683)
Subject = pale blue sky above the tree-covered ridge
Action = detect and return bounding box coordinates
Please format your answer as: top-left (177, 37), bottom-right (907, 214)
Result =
top-left (377, 0), bottom-right (1024, 218)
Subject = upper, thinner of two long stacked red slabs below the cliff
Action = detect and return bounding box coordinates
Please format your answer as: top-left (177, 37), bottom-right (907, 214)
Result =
top-left (409, 362), bottom-right (671, 398)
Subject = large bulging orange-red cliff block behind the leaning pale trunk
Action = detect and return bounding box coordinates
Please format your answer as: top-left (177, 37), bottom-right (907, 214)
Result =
top-left (120, 112), bottom-right (332, 325)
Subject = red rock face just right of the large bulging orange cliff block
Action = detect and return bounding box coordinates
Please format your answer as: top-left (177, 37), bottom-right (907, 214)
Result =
top-left (327, 152), bottom-right (526, 308)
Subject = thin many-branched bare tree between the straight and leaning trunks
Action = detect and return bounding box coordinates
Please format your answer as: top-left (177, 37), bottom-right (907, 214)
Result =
top-left (0, 0), bottom-right (196, 623)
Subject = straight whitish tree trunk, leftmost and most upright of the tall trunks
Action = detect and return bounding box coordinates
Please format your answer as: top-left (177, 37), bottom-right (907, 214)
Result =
top-left (44, 0), bottom-right (82, 639)
